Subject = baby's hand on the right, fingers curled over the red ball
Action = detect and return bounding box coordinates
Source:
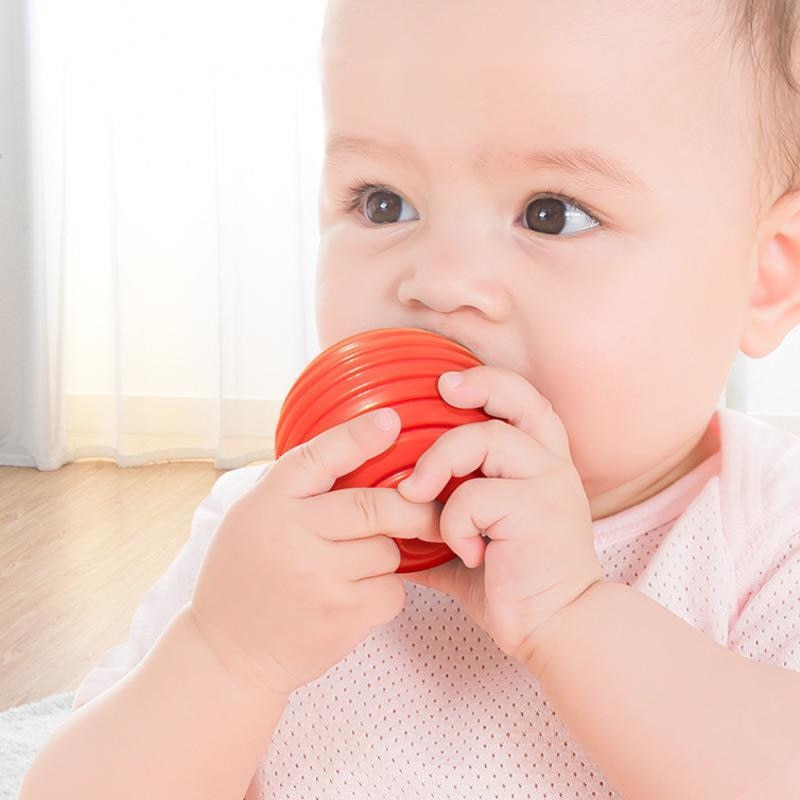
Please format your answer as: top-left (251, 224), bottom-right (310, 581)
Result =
top-left (404, 366), bottom-right (603, 667)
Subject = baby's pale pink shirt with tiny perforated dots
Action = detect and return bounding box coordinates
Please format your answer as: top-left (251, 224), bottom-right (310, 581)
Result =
top-left (73, 408), bottom-right (800, 800)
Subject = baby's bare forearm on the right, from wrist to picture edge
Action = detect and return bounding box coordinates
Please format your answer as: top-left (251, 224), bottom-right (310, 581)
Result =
top-left (528, 581), bottom-right (800, 800)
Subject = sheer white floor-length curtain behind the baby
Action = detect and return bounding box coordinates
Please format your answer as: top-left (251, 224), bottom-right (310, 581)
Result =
top-left (0, 0), bottom-right (800, 470)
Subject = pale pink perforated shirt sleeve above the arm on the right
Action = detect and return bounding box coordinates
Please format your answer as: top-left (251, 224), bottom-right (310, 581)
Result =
top-left (728, 530), bottom-right (800, 672)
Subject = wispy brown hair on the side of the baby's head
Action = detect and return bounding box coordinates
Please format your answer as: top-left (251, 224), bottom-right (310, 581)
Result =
top-left (725, 0), bottom-right (800, 202)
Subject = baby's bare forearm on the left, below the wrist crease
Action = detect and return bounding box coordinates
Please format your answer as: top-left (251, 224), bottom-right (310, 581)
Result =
top-left (20, 605), bottom-right (287, 800)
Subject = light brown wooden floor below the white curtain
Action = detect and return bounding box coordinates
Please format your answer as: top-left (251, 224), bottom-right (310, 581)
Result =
top-left (0, 459), bottom-right (268, 711)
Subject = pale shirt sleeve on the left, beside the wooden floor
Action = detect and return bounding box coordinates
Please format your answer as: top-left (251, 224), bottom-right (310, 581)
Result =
top-left (72, 462), bottom-right (272, 709)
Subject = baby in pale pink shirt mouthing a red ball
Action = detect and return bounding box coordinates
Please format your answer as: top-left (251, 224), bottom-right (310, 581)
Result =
top-left (22, 0), bottom-right (800, 800)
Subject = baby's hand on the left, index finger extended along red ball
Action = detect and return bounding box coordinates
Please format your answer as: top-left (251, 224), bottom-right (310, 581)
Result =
top-left (190, 412), bottom-right (442, 695)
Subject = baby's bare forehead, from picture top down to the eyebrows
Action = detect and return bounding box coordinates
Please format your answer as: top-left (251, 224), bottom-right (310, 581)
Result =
top-left (322, 0), bottom-right (743, 184)
